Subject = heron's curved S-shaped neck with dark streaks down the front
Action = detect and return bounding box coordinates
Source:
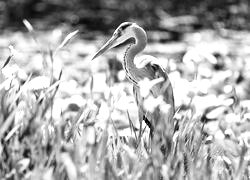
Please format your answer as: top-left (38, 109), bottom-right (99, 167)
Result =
top-left (123, 27), bottom-right (147, 83)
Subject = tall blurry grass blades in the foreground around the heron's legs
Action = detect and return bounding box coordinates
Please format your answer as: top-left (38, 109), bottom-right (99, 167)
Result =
top-left (0, 21), bottom-right (250, 180)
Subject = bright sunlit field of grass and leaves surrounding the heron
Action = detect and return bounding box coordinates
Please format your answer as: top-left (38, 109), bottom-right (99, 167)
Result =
top-left (0, 21), bottom-right (250, 180)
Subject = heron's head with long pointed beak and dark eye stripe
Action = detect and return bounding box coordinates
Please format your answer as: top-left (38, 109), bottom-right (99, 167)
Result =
top-left (92, 22), bottom-right (139, 60)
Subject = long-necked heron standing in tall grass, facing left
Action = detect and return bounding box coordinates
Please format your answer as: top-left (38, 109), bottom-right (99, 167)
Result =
top-left (92, 22), bottom-right (175, 145)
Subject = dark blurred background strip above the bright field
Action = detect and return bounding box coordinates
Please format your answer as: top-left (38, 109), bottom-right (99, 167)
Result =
top-left (0, 0), bottom-right (250, 32)
